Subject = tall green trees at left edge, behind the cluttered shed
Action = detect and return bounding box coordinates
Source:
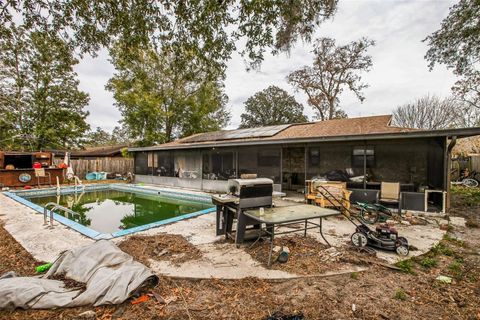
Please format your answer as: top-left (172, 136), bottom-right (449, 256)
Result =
top-left (0, 27), bottom-right (89, 149)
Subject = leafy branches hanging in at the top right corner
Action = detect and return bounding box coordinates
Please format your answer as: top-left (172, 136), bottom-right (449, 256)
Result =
top-left (424, 0), bottom-right (480, 108)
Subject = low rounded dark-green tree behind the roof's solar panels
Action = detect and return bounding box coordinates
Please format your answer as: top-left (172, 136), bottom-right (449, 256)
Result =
top-left (240, 86), bottom-right (308, 128)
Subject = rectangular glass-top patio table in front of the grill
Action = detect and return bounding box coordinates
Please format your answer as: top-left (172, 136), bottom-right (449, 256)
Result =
top-left (243, 204), bottom-right (340, 266)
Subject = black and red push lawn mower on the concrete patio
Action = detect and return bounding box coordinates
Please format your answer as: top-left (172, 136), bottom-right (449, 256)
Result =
top-left (319, 186), bottom-right (409, 256)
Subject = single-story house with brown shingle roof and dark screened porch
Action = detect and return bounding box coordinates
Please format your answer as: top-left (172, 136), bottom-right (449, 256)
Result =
top-left (129, 115), bottom-right (480, 210)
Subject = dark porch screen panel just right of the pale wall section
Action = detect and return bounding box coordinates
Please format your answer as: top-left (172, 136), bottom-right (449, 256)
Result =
top-left (203, 150), bottom-right (236, 180)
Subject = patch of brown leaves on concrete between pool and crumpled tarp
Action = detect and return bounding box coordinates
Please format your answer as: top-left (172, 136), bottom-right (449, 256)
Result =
top-left (118, 234), bottom-right (202, 266)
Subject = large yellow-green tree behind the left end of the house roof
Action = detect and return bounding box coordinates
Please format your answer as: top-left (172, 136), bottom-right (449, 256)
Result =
top-left (107, 44), bottom-right (229, 145)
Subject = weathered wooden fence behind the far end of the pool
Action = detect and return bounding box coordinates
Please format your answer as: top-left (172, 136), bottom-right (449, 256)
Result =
top-left (55, 157), bottom-right (133, 179)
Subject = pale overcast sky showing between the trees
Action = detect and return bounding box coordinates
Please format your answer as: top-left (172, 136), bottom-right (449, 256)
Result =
top-left (76, 0), bottom-right (455, 130)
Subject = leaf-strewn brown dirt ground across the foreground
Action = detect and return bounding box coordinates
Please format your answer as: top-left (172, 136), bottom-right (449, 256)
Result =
top-left (0, 189), bottom-right (480, 319)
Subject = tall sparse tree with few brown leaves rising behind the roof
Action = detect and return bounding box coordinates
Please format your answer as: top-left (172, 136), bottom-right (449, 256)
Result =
top-left (287, 38), bottom-right (375, 120)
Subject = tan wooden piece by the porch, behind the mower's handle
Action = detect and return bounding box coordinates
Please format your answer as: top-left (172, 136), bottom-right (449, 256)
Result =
top-left (315, 181), bottom-right (352, 214)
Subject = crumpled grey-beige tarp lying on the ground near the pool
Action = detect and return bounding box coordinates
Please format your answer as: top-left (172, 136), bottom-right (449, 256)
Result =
top-left (0, 240), bottom-right (158, 309)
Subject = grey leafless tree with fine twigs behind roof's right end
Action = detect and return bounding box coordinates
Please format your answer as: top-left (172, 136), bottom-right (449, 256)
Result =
top-left (393, 95), bottom-right (464, 130)
